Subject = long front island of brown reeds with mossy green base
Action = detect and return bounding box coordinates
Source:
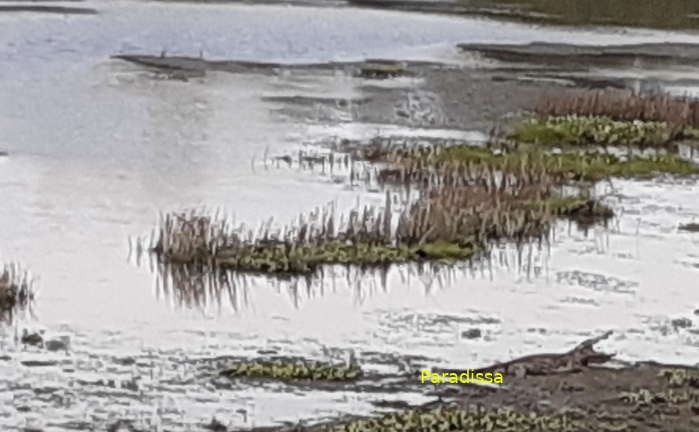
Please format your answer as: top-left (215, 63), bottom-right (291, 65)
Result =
top-left (152, 177), bottom-right (612, 275)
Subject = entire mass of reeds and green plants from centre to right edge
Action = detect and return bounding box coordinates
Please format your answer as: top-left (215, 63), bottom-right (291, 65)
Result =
top-left (141, 88), bottom-right (699, 282)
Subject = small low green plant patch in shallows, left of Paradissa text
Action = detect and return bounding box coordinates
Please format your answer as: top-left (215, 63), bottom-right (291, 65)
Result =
top-left (221, 361), bottom-right (362, 381)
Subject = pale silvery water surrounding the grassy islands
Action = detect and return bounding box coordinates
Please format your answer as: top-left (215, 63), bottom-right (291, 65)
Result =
top-left (0, 2), bottom-right (699, 430)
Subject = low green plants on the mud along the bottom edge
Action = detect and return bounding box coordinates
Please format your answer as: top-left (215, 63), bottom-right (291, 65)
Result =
top-left (318, 408), bottom-right (584, 432)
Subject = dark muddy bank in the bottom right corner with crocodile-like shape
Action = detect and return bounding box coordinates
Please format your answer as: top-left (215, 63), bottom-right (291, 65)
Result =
top-left (243, 332), bottom-right (699, 432)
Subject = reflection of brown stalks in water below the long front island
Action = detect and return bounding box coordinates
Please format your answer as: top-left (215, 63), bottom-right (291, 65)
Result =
top-left (139, 235), bottom-right (572, 314)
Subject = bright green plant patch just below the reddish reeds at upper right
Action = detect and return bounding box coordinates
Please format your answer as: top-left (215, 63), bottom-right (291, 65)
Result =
top-left (511, 115), bottom-right (681, 146)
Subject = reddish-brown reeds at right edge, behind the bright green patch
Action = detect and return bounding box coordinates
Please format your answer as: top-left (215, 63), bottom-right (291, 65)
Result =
top-left (533, 91), bottom-right (699, 128)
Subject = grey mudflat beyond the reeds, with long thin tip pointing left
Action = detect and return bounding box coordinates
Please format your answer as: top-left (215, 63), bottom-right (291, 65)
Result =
top-left (114, 53), bottom-right (572, 130)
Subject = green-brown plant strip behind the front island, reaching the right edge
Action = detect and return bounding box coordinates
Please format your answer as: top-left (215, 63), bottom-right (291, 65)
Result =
top-left (360, 141), bottom-right (699, 183)
